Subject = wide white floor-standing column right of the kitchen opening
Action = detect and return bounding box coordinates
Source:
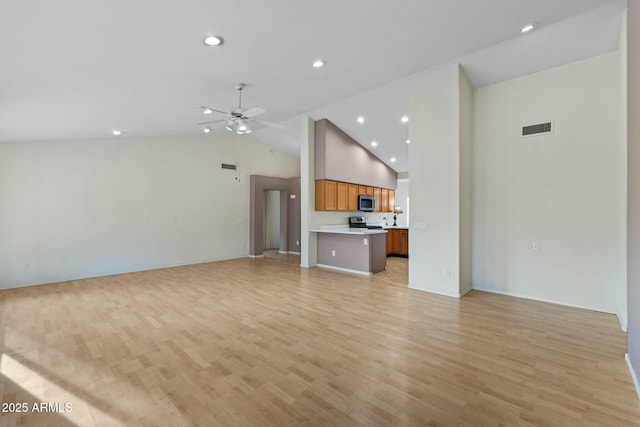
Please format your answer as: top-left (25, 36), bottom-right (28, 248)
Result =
top-left (409, 64), bottom-right (472, 297)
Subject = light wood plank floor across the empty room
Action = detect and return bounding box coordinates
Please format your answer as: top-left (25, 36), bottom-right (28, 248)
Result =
top-left (0, 258), bottom-right (640, 426)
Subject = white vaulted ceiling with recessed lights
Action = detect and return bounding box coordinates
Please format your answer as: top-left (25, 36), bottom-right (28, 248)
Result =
top-left (0, 0), bottom-right (626, 171)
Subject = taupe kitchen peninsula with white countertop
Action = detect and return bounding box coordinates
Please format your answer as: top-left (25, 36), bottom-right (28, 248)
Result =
top-left (311, 225), bottom-right (387, 275)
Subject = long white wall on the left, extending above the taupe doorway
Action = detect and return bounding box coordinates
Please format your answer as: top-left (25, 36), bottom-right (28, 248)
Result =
top-left (0, 134), bottom-right (300, 288)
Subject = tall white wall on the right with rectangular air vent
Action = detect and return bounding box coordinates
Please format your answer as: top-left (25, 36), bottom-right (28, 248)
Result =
top-left (476, 53), bottom-right (626, 313)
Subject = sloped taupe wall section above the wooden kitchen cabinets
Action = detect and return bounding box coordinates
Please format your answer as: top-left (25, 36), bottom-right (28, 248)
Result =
top-left (314, 119), bottom-right (398, 189)
